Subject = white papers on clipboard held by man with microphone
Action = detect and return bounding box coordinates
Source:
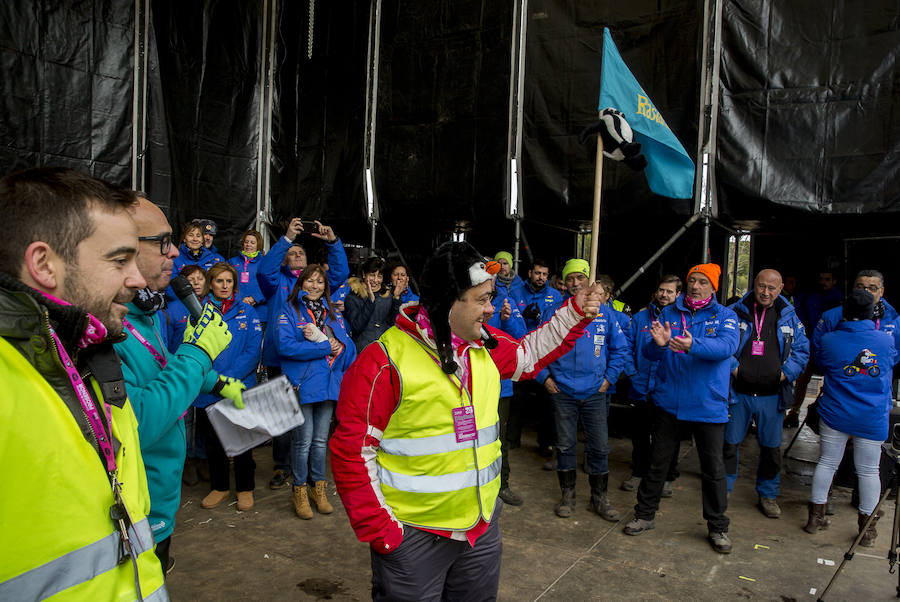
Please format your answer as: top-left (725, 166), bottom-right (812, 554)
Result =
top-left (206, 374), bottom-right (303, 457)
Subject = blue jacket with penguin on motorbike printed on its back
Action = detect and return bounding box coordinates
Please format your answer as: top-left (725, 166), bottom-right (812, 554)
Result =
top-left (815, 320), bottom-right (897, 441)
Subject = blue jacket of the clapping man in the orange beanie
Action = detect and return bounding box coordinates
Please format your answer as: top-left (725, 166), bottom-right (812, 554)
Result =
top-left (644, 295), bottom-right (740, 423)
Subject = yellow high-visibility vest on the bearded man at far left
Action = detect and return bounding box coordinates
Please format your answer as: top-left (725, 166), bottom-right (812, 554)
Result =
top-left (0, 335), bottom-right (169, 602)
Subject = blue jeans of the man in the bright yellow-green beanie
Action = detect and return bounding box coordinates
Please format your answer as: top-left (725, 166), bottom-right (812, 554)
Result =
top-left (553, 392), bottom-right (609, 474)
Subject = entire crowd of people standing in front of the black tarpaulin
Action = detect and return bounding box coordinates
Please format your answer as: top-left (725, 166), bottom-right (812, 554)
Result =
top-left (0, 168), bottom-right (900, 600)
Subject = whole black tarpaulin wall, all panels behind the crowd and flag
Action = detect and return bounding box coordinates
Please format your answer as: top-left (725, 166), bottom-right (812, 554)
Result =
top-left (0, 0), bottom-right (900, 288)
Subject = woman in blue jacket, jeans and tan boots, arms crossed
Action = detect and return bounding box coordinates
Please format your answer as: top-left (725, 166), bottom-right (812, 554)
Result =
top-left (276, 264), bottom-right (356, 519)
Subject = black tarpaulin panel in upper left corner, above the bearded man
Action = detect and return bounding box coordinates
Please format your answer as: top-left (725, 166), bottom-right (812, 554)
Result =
top-left (0, 0), bottom-right (134, 182)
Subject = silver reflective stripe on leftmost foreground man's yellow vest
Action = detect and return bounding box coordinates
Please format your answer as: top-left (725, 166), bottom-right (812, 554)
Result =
top-left (0, 518), bottom-right (156, 600)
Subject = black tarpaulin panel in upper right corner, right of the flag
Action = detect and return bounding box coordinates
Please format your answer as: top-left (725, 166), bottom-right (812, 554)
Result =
top-left (717, 0), bottom-right (900, 220)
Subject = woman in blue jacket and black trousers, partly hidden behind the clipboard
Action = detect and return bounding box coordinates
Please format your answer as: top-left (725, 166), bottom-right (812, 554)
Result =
top-left (194, 262), bottom-right (262, 510)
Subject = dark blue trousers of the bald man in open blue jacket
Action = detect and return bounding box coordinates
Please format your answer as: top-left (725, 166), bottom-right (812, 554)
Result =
top-left (722, 391), bottom-right (784, 499)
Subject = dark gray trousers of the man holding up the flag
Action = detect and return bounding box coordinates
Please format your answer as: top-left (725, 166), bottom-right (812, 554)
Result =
top-left (371, 498), bottom-right (503, 602)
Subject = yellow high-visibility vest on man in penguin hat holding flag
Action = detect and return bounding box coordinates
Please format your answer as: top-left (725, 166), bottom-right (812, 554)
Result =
top-left (376, 327), bottom-right (501, 531)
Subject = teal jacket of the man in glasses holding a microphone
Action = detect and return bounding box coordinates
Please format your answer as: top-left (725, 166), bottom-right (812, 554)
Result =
top-left (115, 303), bottom-right (218, 541)
